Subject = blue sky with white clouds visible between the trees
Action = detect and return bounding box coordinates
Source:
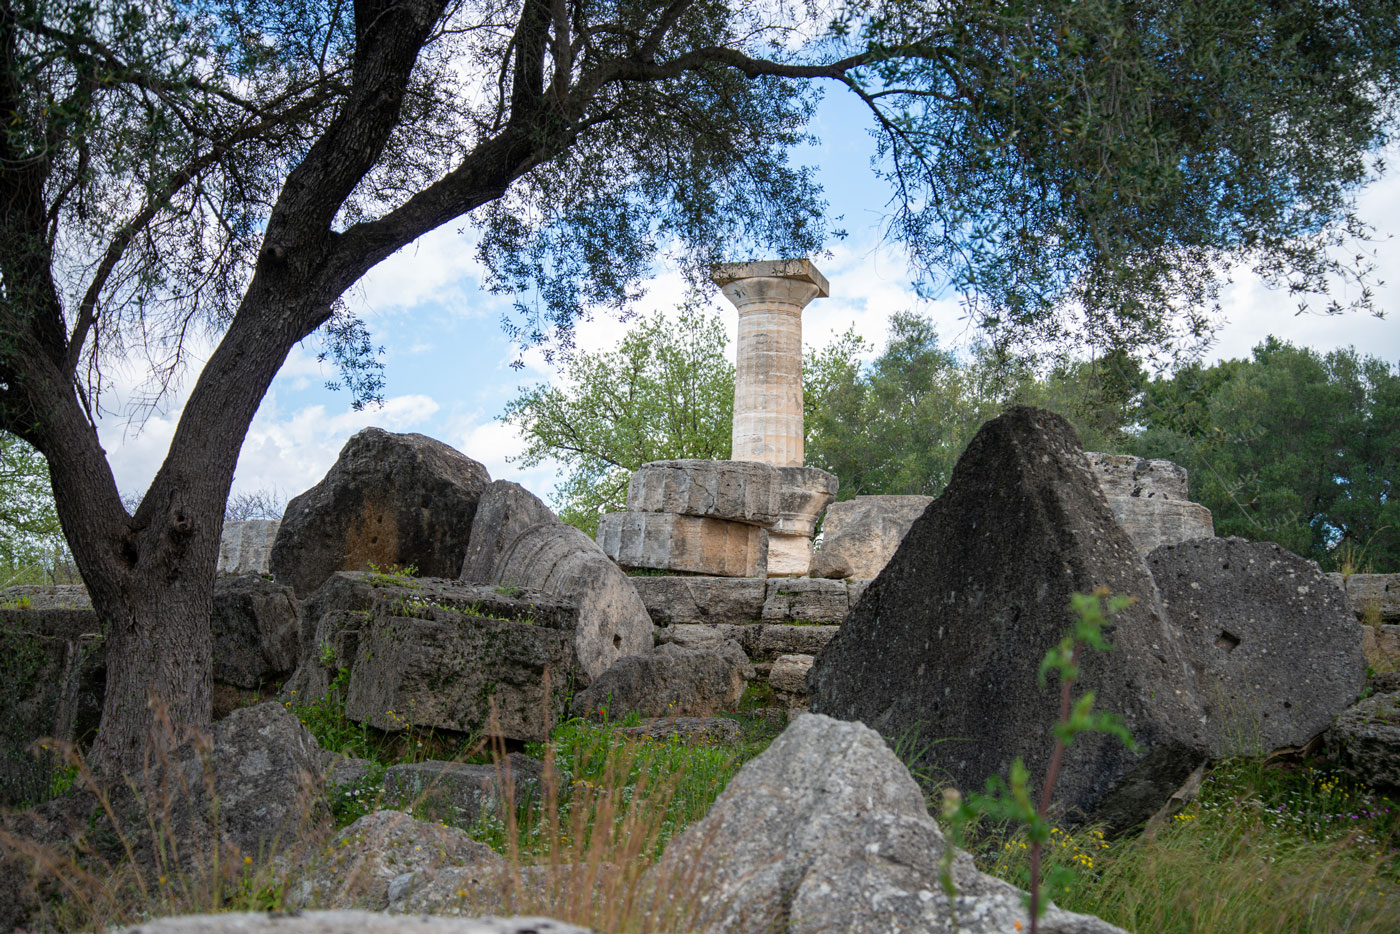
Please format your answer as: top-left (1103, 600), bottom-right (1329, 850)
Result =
top-left (99, 91), bottom-right (1400, 512)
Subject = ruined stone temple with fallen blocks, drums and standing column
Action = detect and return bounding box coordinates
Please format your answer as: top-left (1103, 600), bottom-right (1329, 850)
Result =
top-left (0, 260), bottom-right (1400, 931)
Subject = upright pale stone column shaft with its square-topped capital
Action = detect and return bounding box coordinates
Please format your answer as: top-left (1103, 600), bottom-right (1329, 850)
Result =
top-left (710, 259), bottom-right (830, 466)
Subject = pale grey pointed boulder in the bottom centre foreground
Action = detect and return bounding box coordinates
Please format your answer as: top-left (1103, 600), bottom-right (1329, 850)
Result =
top-left (659, 714), bottom-right (1120, 934)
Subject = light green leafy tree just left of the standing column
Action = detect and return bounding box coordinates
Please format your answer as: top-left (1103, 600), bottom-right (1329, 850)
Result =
top-left (500, 302), bottom-right (734, 535)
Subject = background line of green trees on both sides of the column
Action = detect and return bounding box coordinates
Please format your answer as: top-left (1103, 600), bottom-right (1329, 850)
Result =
top-left (501, 305), bottom-right (1400, 571)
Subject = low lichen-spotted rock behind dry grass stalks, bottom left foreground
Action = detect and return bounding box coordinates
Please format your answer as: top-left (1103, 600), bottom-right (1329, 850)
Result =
top-left (287, 811), bottom-right (505, 923)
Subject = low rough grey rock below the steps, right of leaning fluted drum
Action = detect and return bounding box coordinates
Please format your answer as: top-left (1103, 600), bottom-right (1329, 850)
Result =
top-left (573, 641), bottom-right (753, 718)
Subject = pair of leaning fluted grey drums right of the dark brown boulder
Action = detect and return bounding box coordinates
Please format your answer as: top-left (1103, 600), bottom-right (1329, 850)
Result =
top-left (458, 480), bottom-right (652, 681)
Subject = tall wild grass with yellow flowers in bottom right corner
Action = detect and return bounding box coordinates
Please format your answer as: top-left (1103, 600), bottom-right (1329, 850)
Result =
top-left (974, 759), bottom-right (1400, 934)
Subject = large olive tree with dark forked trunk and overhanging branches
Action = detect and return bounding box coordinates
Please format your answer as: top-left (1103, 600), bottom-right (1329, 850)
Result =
top-left (0, 0), bottom-right (1400, 770)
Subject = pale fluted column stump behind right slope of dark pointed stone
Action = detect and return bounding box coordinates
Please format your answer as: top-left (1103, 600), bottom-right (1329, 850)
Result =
top-left (1084, 451), bottom-right (1215, 557)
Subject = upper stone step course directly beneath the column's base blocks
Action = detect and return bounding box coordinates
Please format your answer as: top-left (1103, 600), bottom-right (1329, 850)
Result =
top-left (627, 576), bottom-right (869, 626)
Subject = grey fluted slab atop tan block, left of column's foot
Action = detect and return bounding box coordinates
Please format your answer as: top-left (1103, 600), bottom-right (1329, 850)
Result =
top-left (627, 459), bottom-right (783, 527)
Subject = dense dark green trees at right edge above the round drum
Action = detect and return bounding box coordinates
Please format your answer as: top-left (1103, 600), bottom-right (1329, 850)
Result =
top-left (1134, 337), bottom-right (1400, 571)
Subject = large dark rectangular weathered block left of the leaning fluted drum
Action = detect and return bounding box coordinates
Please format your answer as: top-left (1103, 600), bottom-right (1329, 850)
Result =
top-left (346, 608), bottom-right (574, 741)
